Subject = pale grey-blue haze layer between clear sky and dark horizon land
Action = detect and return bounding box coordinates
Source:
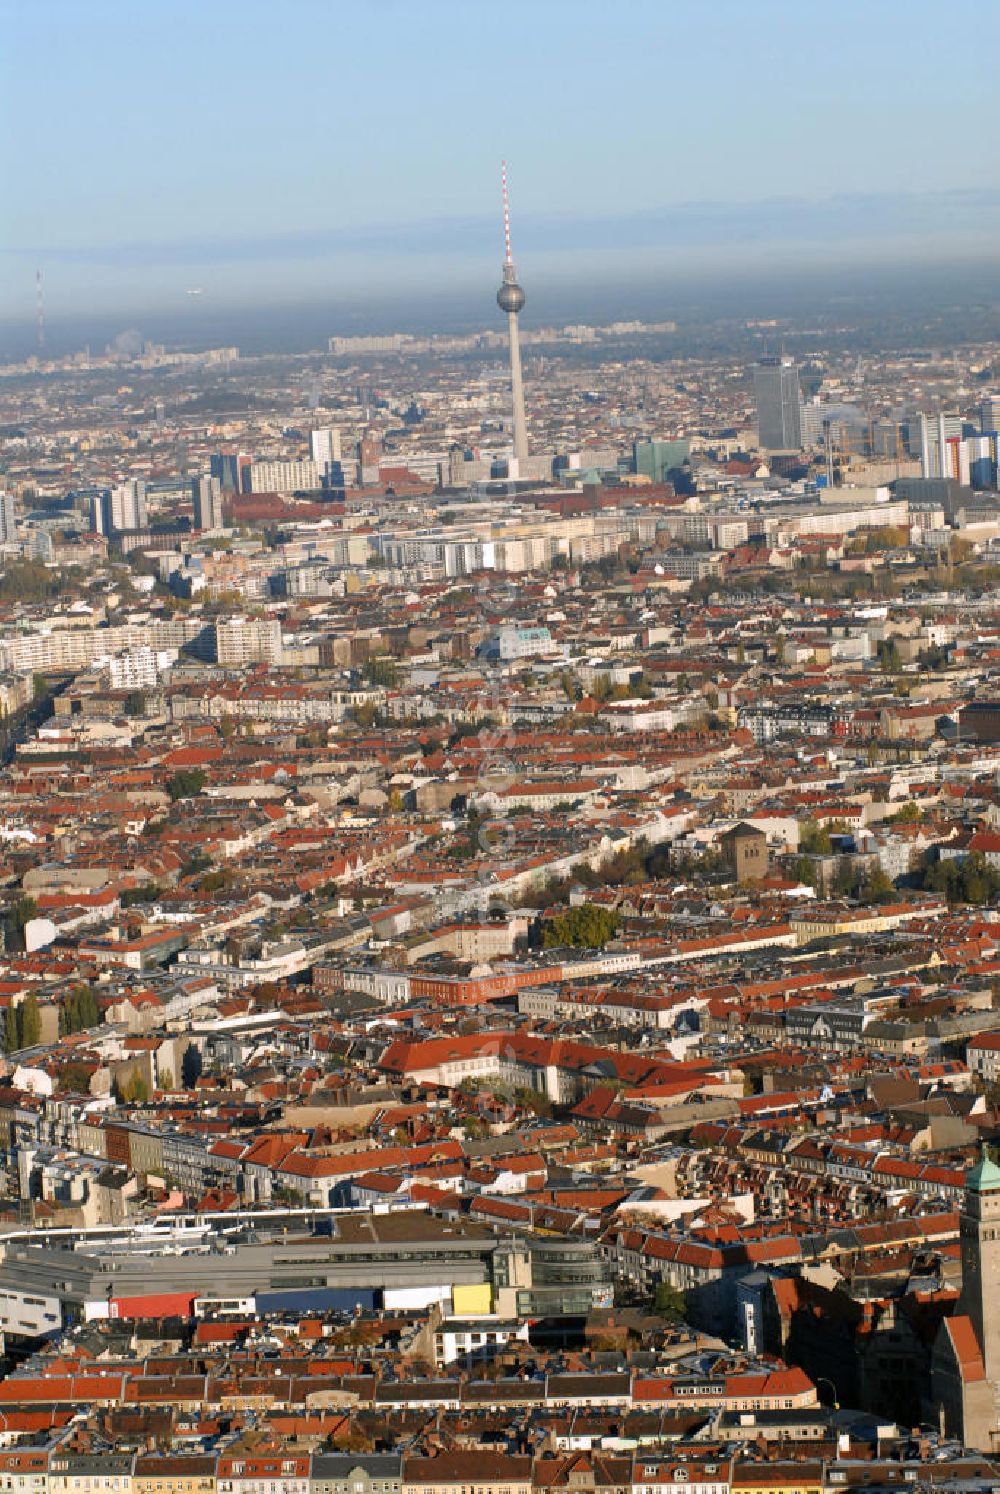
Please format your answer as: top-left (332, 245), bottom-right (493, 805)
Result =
top-left (7, 190), bottom-right (1000, 324)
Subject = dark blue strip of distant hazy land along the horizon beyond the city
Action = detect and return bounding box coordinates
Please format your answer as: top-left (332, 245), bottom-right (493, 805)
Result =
top-left (0, 254), bottom-right (1000, 362)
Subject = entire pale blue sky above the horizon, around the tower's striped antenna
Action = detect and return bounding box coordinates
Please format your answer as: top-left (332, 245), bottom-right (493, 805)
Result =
top-left (0, 0), bottom-right (1000, 317)
